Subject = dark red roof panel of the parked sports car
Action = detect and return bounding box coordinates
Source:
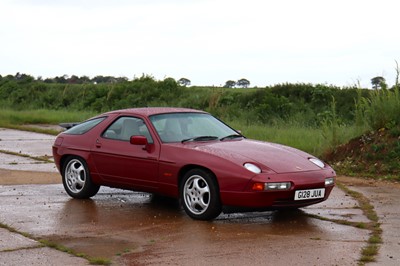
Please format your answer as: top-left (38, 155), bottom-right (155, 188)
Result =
top-left (106, 107), bottom-right (207, 116)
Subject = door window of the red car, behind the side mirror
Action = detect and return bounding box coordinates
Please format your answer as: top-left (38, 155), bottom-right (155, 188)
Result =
top-left (102, 116), bottom-right (153, 143)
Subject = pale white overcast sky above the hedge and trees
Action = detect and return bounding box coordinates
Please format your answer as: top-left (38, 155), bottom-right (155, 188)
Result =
top-left (0, 0), bottom-right (400, 87)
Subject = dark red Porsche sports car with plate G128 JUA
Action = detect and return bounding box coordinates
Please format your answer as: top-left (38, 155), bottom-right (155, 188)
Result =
top-left (53, 108), bottom-right (336, 220)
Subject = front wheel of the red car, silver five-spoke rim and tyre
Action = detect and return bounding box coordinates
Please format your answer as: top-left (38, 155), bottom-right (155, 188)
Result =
top-left (179, 169), bottom-right (222, 220)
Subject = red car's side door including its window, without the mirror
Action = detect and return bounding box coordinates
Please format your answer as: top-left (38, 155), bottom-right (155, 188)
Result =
top-left (92, 116), bottom-right (159, 191)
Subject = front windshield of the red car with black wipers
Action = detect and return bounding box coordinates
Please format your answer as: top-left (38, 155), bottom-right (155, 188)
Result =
top-left (150, 113), bottom-right (240, 142)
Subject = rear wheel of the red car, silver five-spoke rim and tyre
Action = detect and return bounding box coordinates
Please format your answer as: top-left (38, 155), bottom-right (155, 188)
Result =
top-left (62, 156), bottom-right (100, 199)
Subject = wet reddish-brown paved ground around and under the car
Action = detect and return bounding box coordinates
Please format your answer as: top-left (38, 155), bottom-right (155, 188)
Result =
top-left (0, 129), bottom-right (400, 265)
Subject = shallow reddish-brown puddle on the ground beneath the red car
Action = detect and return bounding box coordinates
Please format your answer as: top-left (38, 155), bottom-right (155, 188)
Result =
top-left (44, 190), bottom-right (322, 258)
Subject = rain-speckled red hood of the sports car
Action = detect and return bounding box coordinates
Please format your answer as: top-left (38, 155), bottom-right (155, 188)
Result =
top-left (188, 139), bottom-right (321, 173)
